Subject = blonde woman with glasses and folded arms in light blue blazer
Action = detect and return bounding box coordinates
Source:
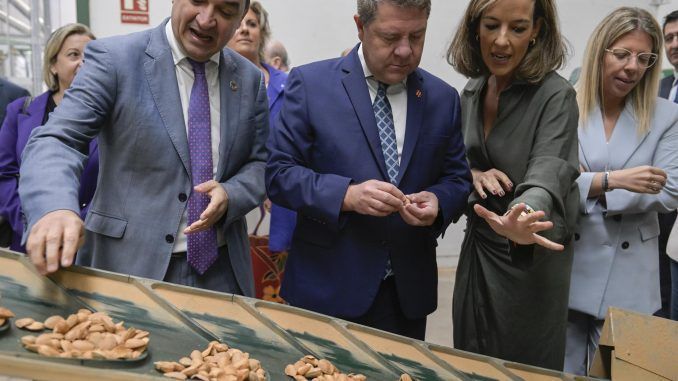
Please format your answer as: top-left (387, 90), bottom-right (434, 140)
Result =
top-left (565, 7), bottom-right (678, 374)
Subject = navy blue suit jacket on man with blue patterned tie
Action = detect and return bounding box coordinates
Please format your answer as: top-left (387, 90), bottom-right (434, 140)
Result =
top-left (266, 48), bottom-right (471, 318)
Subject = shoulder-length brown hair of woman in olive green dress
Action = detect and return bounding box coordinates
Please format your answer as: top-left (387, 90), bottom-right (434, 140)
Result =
top-left (447, 0), bottom-right (567, 83)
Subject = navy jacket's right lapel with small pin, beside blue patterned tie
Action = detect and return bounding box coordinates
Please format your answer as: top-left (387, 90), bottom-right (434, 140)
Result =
top-left (398, 70), bottom-right (426, 184)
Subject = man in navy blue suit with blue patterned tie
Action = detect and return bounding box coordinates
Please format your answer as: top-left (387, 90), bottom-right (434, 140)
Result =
top-left (266, 0), bottom-right (471, 340)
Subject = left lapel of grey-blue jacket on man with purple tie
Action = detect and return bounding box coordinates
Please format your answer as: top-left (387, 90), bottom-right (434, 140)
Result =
top-left (144, 21), bottom-right (191, 176)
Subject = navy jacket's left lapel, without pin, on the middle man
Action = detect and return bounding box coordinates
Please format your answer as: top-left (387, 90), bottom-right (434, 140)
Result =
top-left (341, 47), bottom-right (388, 179)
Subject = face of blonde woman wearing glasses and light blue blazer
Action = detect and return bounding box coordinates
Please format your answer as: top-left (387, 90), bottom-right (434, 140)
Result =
top-left (602, 29), bottom-right (652, 102)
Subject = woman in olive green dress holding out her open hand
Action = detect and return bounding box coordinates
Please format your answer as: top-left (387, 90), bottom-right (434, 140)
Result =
top-left (448, 0), bottom-right (579, 370)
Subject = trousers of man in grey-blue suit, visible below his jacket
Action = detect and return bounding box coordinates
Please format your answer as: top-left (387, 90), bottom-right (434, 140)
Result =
top-left (163, 245), bottom-right (242, 295)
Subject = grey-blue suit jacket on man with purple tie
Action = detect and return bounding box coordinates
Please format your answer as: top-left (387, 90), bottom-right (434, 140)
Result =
top-left (19, 20), bottom-right (268, 295)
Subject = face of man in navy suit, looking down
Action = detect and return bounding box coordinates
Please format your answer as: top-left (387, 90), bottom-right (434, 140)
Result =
top-left (354, 1), bottom-right (428, 85)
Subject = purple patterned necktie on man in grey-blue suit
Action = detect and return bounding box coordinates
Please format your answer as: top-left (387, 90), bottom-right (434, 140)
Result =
top-left (186, 59), bottom-right (217, 275)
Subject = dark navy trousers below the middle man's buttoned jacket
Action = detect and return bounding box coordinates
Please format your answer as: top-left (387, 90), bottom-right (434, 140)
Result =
top-left (343, 276), bottom-right (426, 340)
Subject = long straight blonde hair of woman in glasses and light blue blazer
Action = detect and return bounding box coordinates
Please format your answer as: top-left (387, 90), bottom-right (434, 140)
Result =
top-left (577, 7), bottom-right (663, 133)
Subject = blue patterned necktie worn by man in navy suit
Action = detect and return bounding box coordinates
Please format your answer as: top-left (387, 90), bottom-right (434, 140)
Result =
top-left (372, 82), bottom-right (400, 184)
